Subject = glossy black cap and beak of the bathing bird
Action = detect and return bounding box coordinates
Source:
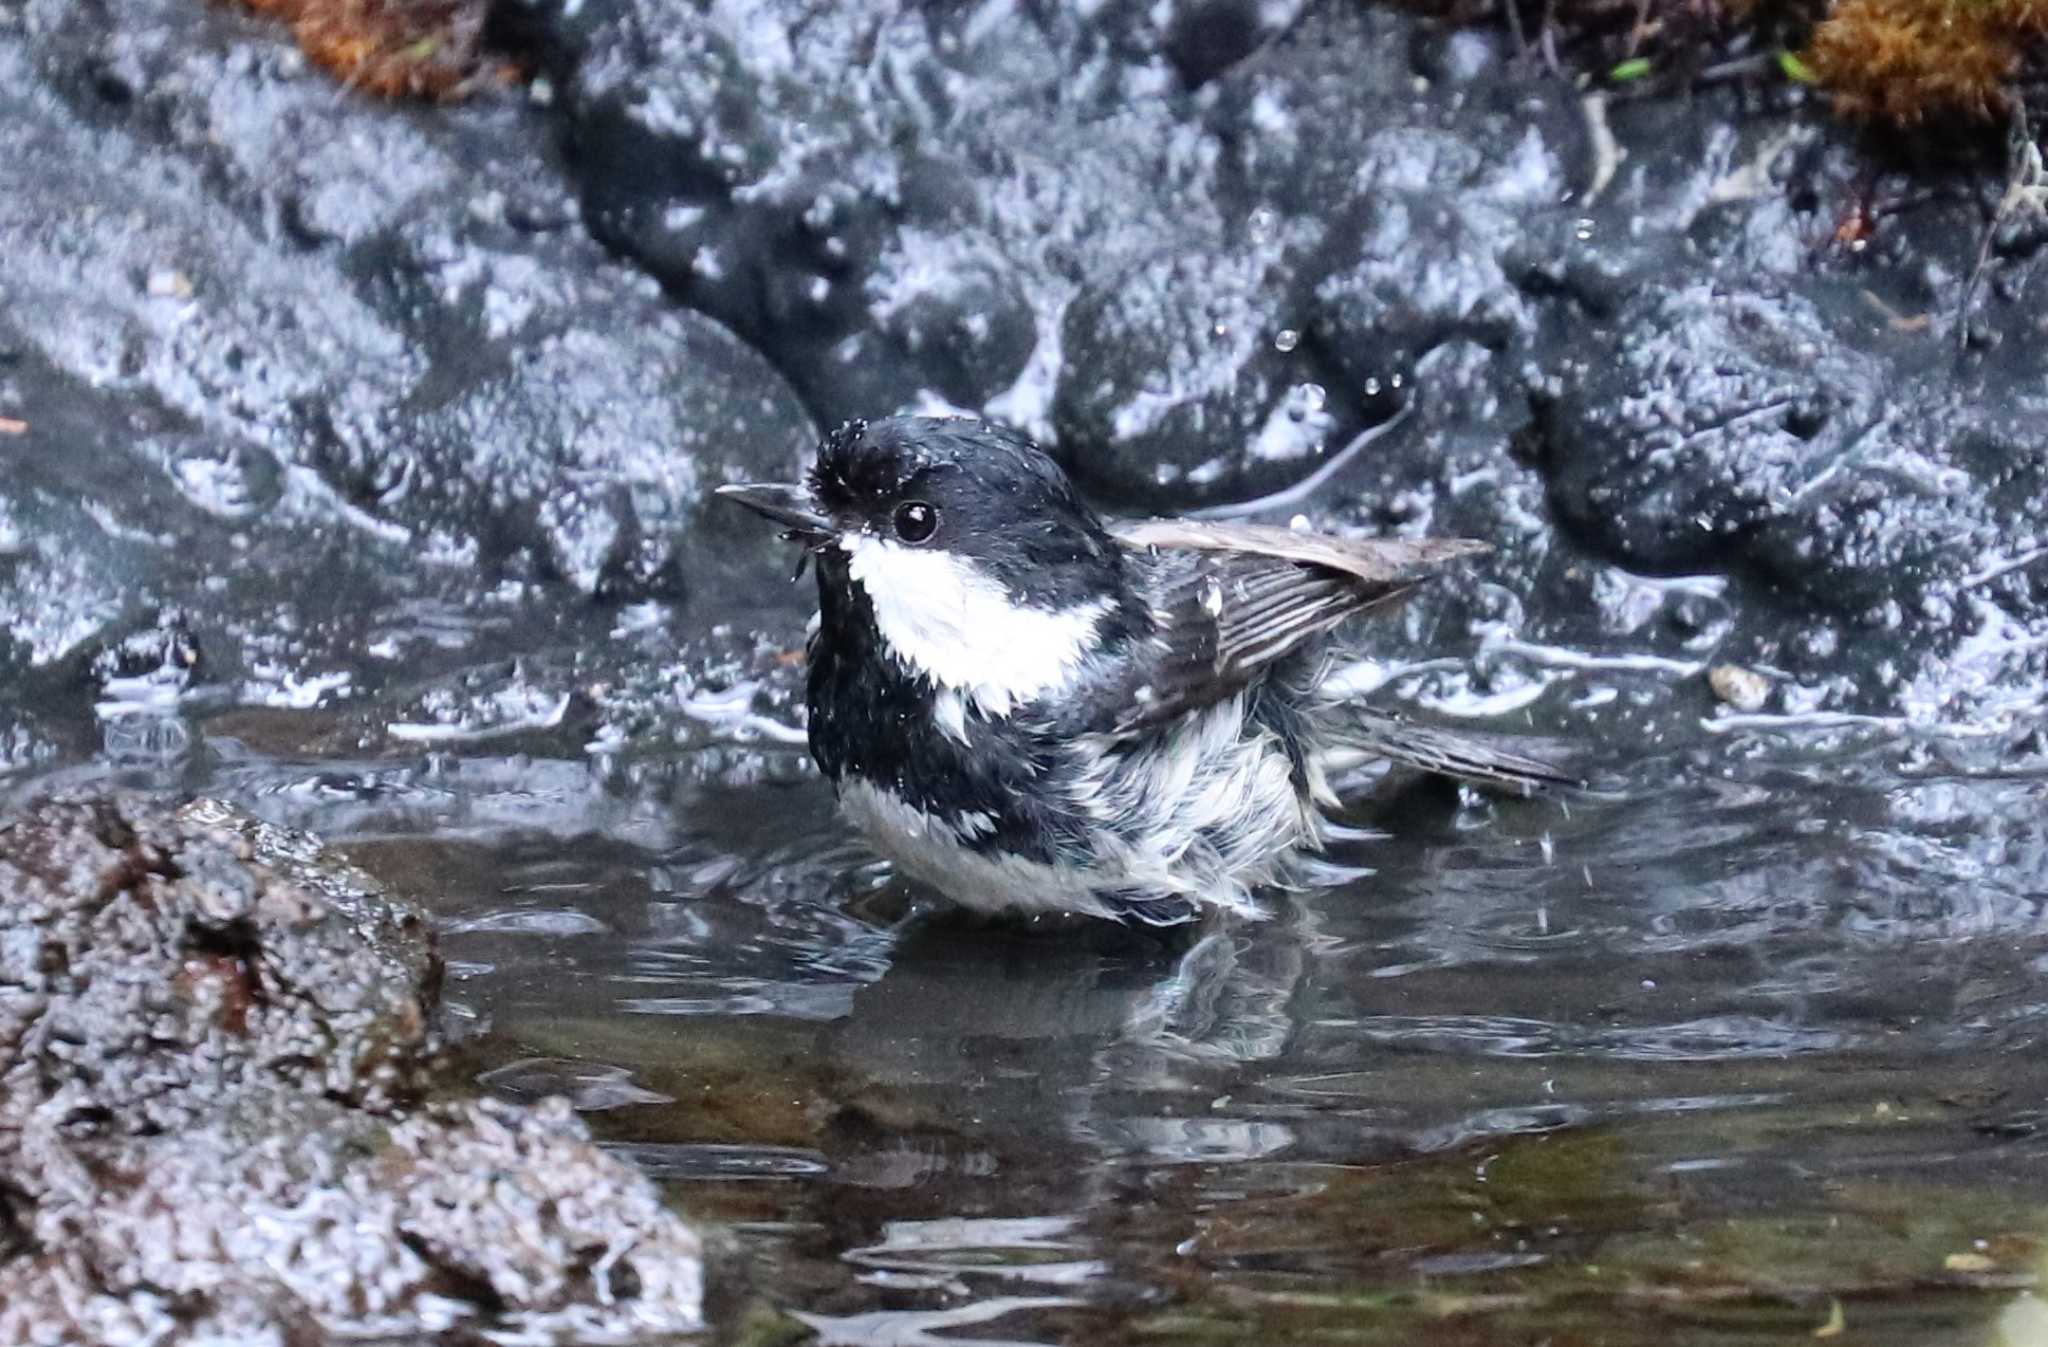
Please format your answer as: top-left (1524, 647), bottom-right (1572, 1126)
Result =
top-left (719, 416), bottom-right (1122, 608)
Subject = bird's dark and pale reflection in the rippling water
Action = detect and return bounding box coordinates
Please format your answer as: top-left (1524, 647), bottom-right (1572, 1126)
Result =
top-left (831, 899), bottom-right (1315, 1161)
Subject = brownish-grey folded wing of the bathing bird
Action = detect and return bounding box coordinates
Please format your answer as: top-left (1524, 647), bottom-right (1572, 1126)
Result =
top-left (1110, 520), bottom-right (1487, 731)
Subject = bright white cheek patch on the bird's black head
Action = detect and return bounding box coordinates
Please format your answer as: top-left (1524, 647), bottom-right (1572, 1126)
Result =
top-left (840, 534), bottom-right (1114, 720)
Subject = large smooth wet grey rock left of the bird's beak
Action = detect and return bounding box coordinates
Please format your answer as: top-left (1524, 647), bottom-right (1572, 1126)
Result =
top-left (0, 0), bottom-right (813, 732)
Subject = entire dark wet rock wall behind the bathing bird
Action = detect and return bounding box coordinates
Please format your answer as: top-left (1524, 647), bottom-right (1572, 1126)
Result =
top-left (12, 0), bottom-right (2048, 762)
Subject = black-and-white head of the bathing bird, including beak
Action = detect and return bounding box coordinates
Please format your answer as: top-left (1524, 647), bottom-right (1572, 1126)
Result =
top-left (719, 418), bottom-right (1133, 714)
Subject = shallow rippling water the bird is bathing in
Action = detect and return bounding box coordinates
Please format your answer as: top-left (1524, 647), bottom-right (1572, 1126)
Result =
top-left (14, 712), bottom-right (2048, 1345)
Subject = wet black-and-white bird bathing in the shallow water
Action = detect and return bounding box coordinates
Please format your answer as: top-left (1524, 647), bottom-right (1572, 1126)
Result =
top-left (717, 416), bottom-right (1573, 925)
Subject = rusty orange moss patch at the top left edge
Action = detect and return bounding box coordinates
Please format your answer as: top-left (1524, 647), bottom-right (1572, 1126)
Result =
top-left (244, 0), bottom-right (520, 98)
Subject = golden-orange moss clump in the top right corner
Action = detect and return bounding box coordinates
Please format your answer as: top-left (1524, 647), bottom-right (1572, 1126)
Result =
top-left (1804, 0), bottom-right (2048, 125)
